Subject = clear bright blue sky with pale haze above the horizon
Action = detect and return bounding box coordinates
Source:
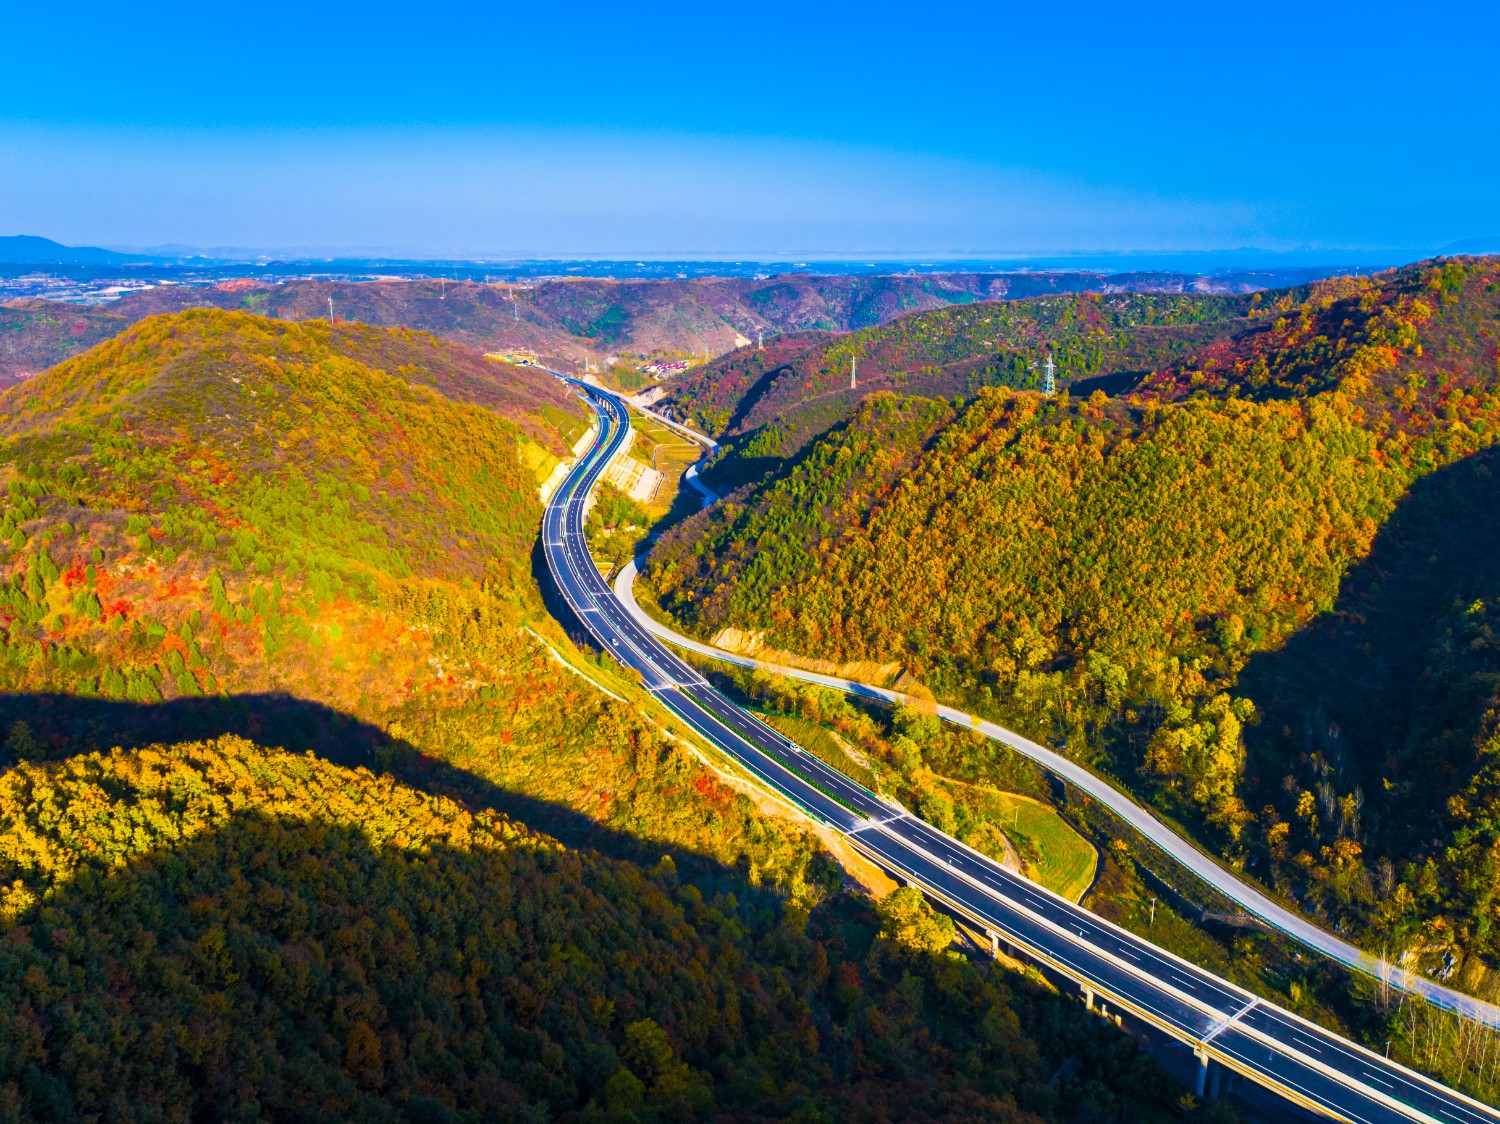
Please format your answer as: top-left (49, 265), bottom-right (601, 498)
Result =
top-left (0, 0), bottom-right (1500, 257)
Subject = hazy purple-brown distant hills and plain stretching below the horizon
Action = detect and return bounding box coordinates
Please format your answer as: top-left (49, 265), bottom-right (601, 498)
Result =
top-left (0, 264), bottom-right (1314, 386)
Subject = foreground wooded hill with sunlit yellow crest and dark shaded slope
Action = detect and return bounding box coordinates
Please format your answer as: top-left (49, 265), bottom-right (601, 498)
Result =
top-left (0, 738), bottom-right (1200, 1119)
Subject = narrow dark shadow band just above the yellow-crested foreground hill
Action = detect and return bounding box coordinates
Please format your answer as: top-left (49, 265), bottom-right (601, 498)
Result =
top-left (0, 693), bottom-right (774, 894)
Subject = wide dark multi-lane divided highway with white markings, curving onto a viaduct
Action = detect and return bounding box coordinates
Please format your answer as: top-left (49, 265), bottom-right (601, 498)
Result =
top-left (542, 380), bottom-right (1500, 1124)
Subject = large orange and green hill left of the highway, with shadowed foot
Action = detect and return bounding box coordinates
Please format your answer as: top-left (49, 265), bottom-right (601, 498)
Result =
top-left (0, 312), bottom-right (834, 884)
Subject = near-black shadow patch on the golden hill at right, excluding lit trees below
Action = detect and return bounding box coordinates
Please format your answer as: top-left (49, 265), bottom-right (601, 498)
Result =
top-left (1239, 438), bottom-right (1500, 855)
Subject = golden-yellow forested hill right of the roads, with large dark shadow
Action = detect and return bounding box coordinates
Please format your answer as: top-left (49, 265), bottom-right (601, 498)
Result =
top-left (647, 258), bottom-right (1500, 987)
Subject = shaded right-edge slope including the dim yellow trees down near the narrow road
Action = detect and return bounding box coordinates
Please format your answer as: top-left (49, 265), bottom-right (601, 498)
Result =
top-left (1239, 447), bottom-right (1500, 966)
